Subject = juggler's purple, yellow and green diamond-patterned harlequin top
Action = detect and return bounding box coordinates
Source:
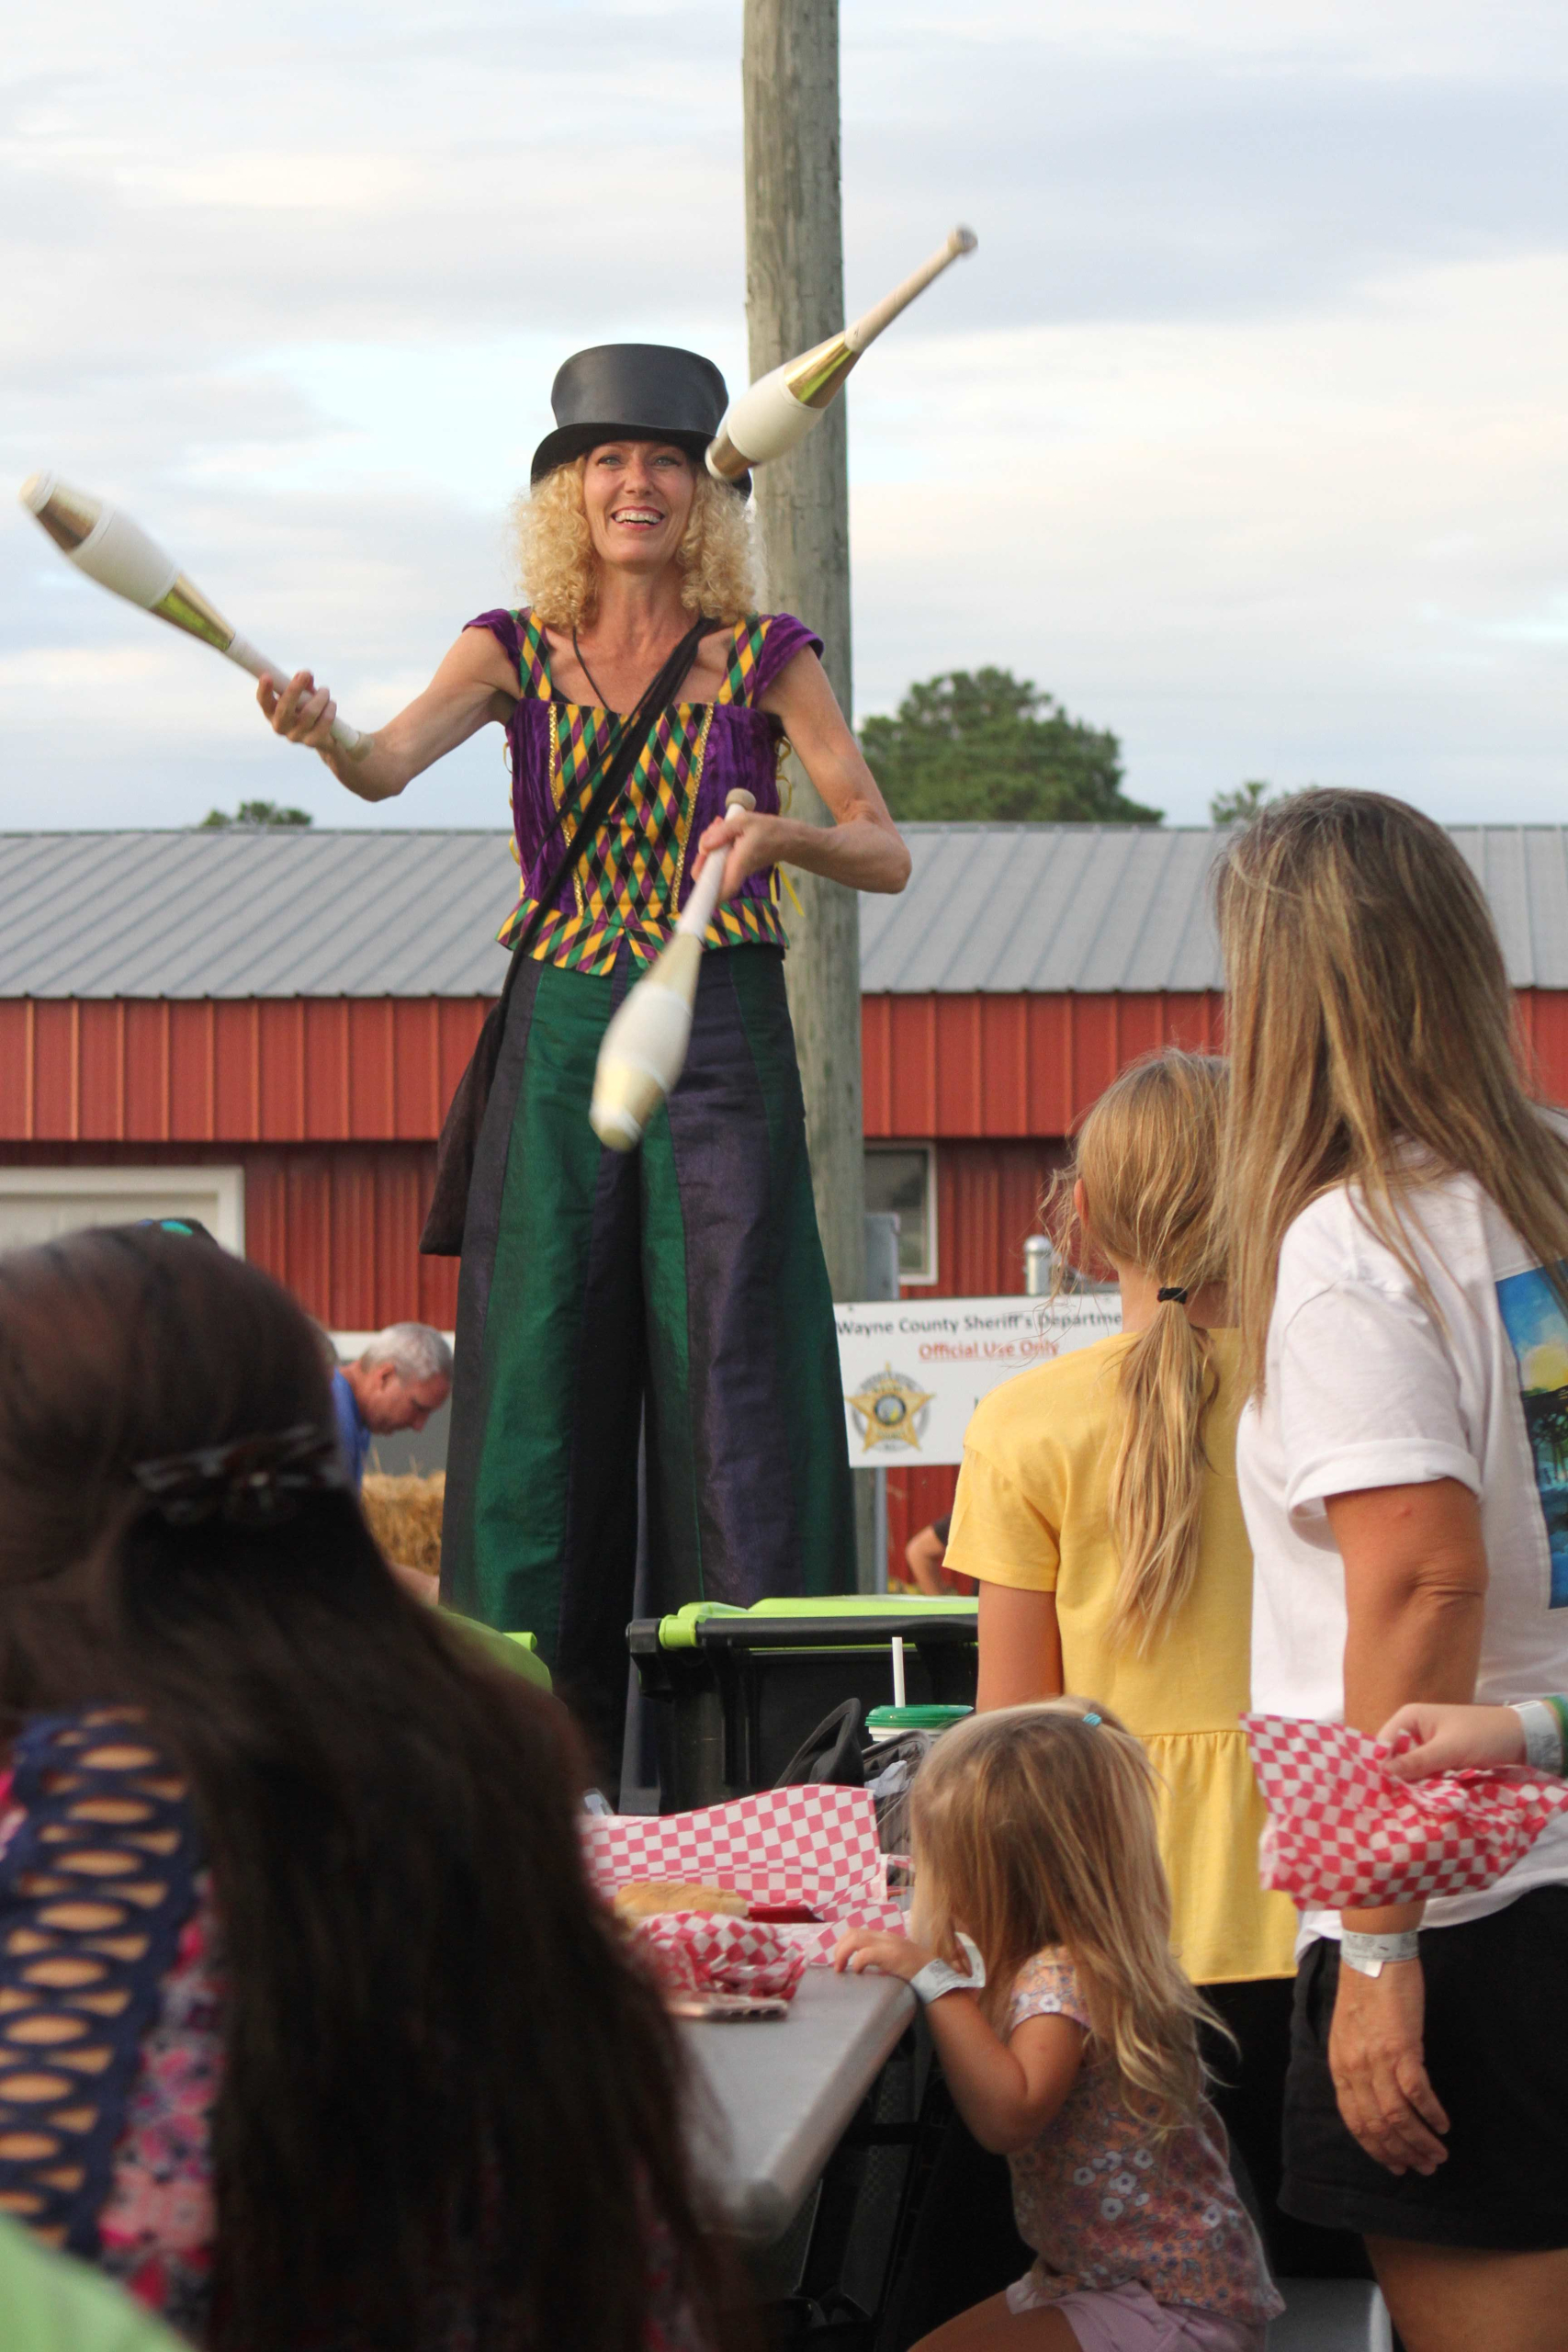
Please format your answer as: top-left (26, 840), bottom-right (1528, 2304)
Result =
top-left (468, 609), bottom-right (823, 974)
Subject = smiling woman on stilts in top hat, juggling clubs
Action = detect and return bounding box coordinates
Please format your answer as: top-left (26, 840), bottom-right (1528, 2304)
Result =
top-left (259, 344), bottom-right (909, 1771)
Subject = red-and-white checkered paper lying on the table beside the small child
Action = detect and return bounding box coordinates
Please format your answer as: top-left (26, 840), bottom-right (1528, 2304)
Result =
top-left (583, 1782), bottom-right (903, 1962)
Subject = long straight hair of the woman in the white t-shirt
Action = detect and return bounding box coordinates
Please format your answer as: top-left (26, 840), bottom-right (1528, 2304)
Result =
top-left (1215, 790), bottom-right (1568, 1395)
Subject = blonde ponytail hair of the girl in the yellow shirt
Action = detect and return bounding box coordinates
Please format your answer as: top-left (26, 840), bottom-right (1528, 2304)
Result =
top-left (1046, 1046), bottom-right (1227, 1651)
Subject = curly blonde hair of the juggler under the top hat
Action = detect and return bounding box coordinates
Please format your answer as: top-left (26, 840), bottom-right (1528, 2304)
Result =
top-left (513, 457), bottom-right (761, 628)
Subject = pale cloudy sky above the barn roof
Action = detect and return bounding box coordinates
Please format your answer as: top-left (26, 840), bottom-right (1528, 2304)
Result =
top-left (0, 0), bottom-right (1568, 826)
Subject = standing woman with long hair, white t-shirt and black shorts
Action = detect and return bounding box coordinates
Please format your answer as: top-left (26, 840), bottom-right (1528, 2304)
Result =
top-left (1218, 793), bottom-right (1568, 2352)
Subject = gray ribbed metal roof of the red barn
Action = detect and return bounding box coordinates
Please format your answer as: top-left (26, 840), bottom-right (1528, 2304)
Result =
top-left (0, 826), bottom-right (1568, 997)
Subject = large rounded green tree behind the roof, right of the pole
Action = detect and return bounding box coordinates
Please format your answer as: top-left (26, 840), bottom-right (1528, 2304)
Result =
top-left (861, 668), bottom-right (1161, 826)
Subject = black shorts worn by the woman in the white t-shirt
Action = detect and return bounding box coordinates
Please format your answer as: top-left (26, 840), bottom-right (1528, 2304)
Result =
top-left (1279, 1886), bottom-right (1568, 2253)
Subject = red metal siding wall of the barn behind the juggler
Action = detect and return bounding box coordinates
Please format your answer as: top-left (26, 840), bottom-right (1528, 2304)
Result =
top-left (0, 990), bottom-right (1568, 1559)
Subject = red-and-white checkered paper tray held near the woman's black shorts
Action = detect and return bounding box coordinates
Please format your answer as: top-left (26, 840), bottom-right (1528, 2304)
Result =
top-left (1241, 1714), bottom-right (1568, 1910)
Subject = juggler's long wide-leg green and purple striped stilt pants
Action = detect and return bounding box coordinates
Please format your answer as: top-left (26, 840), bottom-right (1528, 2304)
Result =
top-left (442, 945), bottom-right (856, 1767)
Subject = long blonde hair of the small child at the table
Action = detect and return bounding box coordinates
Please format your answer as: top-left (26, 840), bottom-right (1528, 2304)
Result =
top-left (909, 1698), bottom-right (1208, 2133)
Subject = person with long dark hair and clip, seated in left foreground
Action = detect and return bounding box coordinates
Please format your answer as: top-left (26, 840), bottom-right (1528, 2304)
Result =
top-left (0, 1227), bottom-right (728, 2352)
